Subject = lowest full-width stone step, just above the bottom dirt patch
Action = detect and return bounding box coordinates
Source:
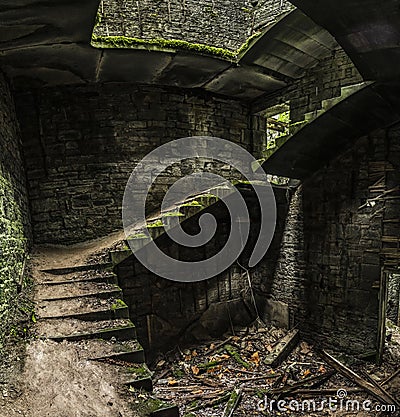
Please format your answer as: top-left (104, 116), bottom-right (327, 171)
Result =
top-left (36, 319), bottom-right (136, 341)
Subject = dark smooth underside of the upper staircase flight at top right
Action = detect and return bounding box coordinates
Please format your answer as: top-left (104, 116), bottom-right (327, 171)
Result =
top-left (263, 0), bottom-right (400, 180)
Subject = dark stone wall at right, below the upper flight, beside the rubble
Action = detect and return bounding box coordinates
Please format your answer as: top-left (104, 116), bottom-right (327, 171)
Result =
top-left (264, 128), bottom-right (400, 354)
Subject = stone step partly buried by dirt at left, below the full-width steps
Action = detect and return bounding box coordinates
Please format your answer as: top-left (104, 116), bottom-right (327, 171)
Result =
top-left (79, 339), bottom-right (145, 363)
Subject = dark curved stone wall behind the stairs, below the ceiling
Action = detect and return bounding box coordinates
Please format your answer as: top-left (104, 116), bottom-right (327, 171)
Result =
top-left (17, 84), bottom-right (265, 244)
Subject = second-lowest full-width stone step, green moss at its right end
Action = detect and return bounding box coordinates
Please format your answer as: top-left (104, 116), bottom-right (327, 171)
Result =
top-left (36, 297), bottom-right (129, 321)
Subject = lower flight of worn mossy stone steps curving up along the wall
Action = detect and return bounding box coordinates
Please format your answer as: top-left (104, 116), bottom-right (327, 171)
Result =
top-left (34, 187), bottom-right (241, 417)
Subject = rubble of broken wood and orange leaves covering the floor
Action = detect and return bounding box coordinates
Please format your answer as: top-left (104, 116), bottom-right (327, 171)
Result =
top-left (132, 321), bottom-right (400, 417)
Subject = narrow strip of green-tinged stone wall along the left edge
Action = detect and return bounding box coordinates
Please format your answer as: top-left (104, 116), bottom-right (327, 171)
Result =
top-left (0, 74), bottom-right (30, 348)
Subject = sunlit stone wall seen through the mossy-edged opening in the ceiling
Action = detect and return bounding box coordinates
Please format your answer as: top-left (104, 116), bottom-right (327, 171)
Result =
top-left (94, 0), bottom-right (293, 50)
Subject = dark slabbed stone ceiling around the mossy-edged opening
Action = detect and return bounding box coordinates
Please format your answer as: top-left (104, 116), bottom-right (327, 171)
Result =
top-left (0, 0), bottom-right (337, 102)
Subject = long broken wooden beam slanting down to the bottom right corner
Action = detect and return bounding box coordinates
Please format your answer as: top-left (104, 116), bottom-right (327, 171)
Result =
top-left (320, 350), bottom-right (400, 406)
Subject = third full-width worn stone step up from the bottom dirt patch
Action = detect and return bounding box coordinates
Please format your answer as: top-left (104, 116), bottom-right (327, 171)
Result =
top-left (36, 282), bottom-right (122, 301)
